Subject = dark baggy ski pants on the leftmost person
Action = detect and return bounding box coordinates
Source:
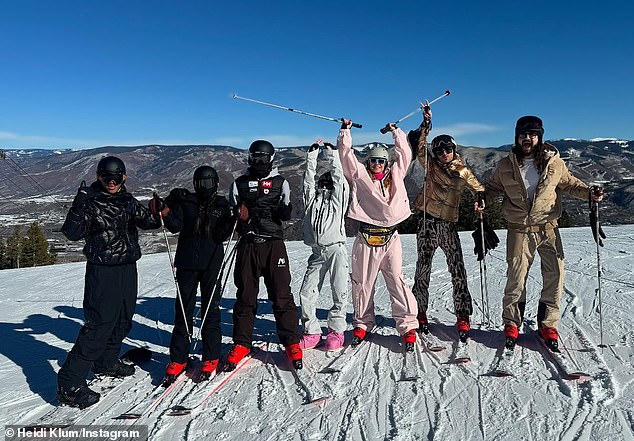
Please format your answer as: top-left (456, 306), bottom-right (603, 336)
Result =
top-left (57, 263), bottom-right (138, 387)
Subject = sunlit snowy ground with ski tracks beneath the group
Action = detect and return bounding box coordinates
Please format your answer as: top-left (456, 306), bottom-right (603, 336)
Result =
top-left (0, 226), bottom-right (634, 441)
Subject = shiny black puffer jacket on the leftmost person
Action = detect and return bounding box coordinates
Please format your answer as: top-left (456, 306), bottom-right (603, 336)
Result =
top-left (62, 181), bottom-right (161, 265)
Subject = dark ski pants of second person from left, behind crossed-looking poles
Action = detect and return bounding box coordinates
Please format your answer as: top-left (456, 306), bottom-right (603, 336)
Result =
top-left (170, 268), bottom-right (222, 363)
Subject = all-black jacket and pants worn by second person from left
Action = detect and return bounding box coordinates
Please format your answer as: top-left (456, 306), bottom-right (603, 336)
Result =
top-left (164, 189), bottom-right (235, 363)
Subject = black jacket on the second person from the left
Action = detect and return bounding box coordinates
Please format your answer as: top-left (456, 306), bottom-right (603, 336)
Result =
top-left (164, 188), bottom-right (235, 270)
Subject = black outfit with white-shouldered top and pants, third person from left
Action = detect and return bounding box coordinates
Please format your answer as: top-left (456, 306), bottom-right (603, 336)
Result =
top-left (229, 169), bottom-right (300, 348)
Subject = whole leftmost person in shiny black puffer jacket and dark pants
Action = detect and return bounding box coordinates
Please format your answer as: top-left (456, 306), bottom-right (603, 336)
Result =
top-left (57, 156), bottom-right (161, 408)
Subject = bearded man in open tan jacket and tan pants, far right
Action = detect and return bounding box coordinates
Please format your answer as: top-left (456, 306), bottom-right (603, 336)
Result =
top-left (486, 115), bottom-right (603, 350)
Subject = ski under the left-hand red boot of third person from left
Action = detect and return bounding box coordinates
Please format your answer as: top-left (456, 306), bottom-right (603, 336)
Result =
top-left (166, 343), bottom-right (268, 416)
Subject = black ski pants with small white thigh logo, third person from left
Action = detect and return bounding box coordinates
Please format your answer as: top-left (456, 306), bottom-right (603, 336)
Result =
top-left (233, 236), bottom-right (300, 348)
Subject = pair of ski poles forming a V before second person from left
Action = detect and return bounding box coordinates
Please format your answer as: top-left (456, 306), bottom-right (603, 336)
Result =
top-left (160, 214), bottom-right (238, 353)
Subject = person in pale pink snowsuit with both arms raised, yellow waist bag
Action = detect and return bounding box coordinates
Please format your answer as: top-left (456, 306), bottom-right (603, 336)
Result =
top-left (337, 119), bottom-right (418, 345)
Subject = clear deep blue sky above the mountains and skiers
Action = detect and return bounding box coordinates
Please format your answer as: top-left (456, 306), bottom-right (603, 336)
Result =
top-left (0, 0), bottom-right (634, 149)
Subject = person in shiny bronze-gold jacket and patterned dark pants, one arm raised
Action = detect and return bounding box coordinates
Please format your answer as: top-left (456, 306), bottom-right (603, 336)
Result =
top-left (409, 106), bottom-right (484, 341)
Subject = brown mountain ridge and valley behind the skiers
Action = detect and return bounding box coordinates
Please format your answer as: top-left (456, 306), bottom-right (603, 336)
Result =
top-left (0, 138), bottom-right (634, 244)
